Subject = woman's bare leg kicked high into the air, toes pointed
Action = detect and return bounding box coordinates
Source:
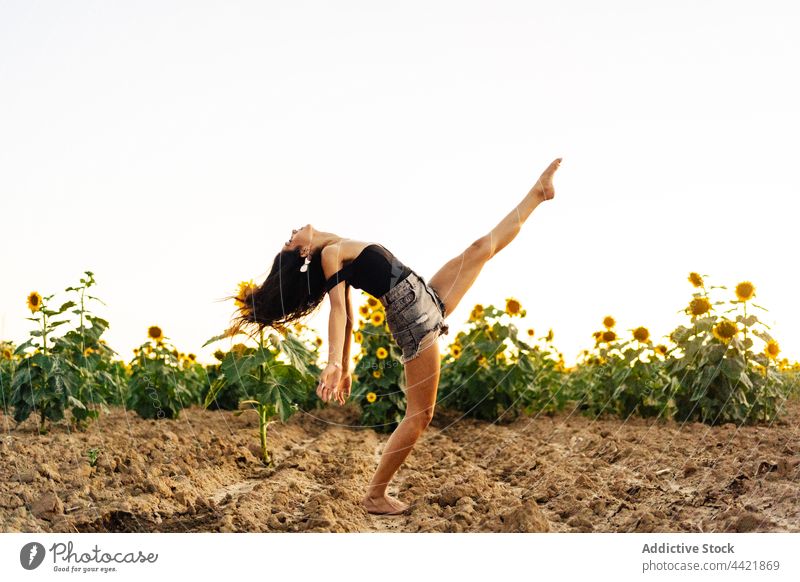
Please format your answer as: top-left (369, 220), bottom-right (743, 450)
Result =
top-left (428, 158), bottom-right (561, 315)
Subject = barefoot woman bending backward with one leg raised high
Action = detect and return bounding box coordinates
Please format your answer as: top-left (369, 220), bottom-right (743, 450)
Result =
top-left (231, 158), bottom-right (561, 515)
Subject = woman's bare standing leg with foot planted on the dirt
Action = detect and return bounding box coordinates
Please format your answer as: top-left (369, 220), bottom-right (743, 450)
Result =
top-left (361, 342), bottom-right (440, 515)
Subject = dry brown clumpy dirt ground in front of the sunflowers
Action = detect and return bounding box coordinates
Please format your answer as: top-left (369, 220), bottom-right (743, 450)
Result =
top-left (0, 401), bottom-right (800, 532)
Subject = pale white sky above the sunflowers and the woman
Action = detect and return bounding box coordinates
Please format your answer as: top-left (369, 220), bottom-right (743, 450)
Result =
top-left (0, 0), bottom-right (800, 364)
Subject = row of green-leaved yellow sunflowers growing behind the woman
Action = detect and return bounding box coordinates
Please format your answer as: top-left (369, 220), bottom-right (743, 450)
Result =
top-left (0, 271), bottom-right (800, 464)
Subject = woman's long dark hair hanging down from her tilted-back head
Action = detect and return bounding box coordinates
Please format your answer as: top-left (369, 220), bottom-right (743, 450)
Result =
top-left (220, 248), bottom-right (325, 338)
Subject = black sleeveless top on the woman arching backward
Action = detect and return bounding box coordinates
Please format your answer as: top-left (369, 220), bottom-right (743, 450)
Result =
top-left (325, 244), bottom-right (411, 298)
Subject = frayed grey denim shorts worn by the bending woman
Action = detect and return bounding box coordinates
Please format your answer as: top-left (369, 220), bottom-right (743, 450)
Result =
top-left (378, 270), bottom-right (449, 364)
